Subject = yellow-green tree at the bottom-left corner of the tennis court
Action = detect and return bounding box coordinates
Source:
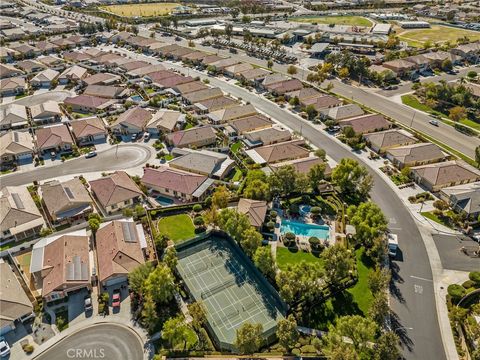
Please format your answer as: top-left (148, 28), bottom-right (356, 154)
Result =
top-left (162, 315), bottom-right (198, 350)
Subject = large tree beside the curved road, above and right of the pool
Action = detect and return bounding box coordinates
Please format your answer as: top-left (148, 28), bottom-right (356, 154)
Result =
top-left (332, 158), bottom-right (373, 198)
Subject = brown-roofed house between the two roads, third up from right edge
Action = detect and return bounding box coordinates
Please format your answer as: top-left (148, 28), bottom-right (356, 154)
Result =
top-left (387, 143), bottom-right (447, 169)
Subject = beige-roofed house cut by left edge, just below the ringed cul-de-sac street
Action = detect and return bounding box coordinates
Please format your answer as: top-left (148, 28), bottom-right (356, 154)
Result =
top-left (0, 186), bottom-right (45, 242)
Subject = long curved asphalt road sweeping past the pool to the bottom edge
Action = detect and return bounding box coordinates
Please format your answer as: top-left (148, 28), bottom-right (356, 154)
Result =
top-left (167, 65), bottom-right (446, 360)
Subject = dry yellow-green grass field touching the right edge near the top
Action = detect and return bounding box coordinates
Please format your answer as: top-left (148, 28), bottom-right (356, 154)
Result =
top-left (397, 25), bottom-right (480, 47)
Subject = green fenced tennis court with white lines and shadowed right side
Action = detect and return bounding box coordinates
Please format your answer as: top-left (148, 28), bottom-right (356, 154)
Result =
top-left (177, 236), bottom-right (285, 350)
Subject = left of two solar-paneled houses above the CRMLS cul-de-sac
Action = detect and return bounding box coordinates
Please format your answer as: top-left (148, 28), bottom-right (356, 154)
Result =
top-left (30, 229), bottom-right (93, 302)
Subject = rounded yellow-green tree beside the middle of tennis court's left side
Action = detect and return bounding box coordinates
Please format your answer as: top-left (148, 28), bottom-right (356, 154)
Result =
top-left (145, 263), bottom-right (175, 304)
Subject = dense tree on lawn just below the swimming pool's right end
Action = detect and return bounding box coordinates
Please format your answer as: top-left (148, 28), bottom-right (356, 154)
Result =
top-left (320, 244), bottom-right (354, 285)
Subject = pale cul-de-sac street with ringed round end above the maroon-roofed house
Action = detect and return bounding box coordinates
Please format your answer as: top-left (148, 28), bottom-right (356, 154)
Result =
top-left (0, 144), bottom-right (154, 187)
